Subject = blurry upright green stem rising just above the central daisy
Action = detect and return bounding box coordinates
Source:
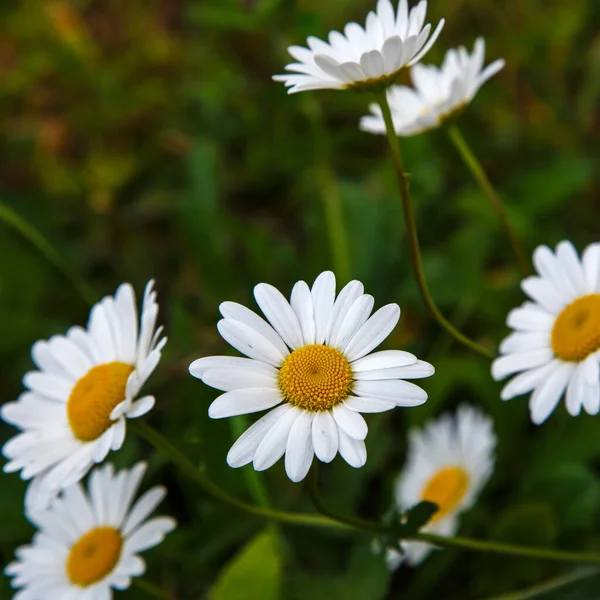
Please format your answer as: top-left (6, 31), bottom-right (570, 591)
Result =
top-left (304, 98), bottom-right (350, 281)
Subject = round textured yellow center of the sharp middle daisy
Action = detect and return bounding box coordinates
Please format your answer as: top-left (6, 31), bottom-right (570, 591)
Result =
top-left (279, 344), bottom-right (353, 411)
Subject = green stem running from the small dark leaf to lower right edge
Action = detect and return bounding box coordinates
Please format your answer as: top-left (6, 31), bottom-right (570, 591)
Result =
top-left (414, 533), bottom-right (600, 565)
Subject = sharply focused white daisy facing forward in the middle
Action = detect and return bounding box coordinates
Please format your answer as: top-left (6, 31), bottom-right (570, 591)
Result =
top-left (190, 271), bottom-right (434, 481)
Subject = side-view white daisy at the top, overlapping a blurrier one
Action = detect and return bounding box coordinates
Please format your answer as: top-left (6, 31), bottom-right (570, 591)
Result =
top-left (273, 0), bottom-right (444, 94)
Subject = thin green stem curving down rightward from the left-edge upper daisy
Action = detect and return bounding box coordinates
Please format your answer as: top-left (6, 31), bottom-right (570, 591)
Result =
top-left (131, 421), bottom-right (350, 530)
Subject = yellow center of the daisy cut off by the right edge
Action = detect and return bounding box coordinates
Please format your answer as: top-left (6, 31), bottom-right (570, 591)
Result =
top-left (552, 294), bottom-right (600, 362)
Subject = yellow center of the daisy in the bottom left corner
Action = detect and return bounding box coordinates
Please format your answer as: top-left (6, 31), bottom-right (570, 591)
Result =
top-left (67, 527), bottom-right (123, 587)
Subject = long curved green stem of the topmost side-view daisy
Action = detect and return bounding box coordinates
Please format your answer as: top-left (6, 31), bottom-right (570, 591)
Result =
top-left (377, 91), bottom-right (495, 360)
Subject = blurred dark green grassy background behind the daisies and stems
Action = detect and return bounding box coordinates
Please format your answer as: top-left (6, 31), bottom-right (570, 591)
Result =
top-left (0, 0), bottom-right (600, 600)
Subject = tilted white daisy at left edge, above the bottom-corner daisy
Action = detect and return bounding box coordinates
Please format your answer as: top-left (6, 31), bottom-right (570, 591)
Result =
top-left (0, 281), bottom-right (166, 509)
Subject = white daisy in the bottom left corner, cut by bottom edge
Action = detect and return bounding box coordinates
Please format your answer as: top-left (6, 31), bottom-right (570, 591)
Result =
top-left (5, 463), bottom-right (176, 600)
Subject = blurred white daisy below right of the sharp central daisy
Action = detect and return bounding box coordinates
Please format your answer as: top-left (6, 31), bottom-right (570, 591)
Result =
top-left (387, 406), bottom-right (496, 568)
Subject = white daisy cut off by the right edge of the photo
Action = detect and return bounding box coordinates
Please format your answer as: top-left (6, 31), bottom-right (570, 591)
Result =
top-left (492, 242), bottom-right (600, 424)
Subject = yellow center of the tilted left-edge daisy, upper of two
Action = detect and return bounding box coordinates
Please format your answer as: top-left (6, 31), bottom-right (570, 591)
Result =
top-left (67, 361), bottom-right (133, 442)
